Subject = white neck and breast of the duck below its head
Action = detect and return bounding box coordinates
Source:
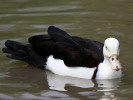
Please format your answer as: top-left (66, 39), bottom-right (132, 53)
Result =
top-left (96, 57), bottom-right (121, 79)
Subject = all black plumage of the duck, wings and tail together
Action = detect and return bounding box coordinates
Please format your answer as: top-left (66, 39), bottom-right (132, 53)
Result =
top-left (2, 26), bottom-right (103, 68)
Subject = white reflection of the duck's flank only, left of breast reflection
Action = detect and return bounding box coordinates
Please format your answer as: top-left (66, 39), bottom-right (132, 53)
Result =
top-left (46, 71), bottom-right (94, 91)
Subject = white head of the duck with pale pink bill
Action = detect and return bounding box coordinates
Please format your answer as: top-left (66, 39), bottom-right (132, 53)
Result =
top-left (103, 38), bottom-right (121, 71)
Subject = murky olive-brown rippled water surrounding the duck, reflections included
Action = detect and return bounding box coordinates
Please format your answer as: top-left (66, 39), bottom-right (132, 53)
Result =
top-left (0, 0), bottom-right (133, 100)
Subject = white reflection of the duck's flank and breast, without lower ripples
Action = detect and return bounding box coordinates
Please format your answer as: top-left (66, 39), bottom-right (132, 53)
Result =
top-left (46, 71), bottom-right (120, 91)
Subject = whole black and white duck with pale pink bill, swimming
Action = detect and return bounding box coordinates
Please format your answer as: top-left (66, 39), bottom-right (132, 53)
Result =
top-left (2, 26), bottom-right (122, 79)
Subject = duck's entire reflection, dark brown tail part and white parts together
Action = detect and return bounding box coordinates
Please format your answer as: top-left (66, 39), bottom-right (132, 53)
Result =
top-left (6, 67), bottom-right (121, 100)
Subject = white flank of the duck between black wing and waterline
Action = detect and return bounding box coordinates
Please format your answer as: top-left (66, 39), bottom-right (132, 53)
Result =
top-left (46, 55), bottom-right (96, 79)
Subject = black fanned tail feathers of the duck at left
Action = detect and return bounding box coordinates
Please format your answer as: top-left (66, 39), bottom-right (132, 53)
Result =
top-left (2, 40), bottom-right (46, 69)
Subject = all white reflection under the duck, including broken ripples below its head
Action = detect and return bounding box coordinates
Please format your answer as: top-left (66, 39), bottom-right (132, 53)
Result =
top-left (46, 71), bottom-right (120, 100)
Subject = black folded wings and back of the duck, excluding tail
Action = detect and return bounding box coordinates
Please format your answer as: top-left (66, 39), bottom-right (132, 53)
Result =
top-left (29, 26), bottom-right (103, 67)
